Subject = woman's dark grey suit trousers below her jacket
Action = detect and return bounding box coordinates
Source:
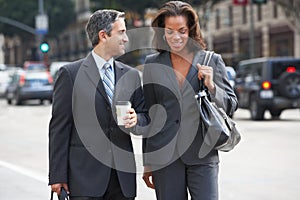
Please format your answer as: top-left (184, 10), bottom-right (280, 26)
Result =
top-left (152, 159), bottom-right (219, 200)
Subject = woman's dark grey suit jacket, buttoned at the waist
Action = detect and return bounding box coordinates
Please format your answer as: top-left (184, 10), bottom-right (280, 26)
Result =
top-left (143, 51), bottom-right (237, 166)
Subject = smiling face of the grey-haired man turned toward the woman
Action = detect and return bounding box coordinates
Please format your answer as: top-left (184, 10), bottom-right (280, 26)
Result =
top-left (106, 18), bottom-right (128, 56)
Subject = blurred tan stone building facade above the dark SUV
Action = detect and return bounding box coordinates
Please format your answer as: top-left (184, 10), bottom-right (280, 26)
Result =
top-left (204, 0), bottom-right (300, 65)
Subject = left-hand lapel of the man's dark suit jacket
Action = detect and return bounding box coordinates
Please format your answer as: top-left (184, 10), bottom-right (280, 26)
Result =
top-left (83, 53), bottom-right (109, 103)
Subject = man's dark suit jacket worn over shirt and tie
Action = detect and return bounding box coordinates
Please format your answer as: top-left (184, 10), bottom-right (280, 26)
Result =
top-left (49, 54), bottom-right (145, 197)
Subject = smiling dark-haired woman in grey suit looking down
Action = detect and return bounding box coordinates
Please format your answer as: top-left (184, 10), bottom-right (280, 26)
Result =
top-left (143, 1), bottom-right (237, 200)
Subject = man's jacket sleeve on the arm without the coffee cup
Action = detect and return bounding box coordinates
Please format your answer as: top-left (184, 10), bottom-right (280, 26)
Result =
top-left (49, 67), bottom-right (73, 185)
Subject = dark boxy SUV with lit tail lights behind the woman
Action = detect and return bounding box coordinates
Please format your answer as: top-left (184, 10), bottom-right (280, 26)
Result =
top-left (235, 57), bottom-right (300, 120)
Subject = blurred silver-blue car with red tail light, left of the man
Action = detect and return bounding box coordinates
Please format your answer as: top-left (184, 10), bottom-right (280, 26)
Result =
top-left (6, 70), bottom-right (53, 105)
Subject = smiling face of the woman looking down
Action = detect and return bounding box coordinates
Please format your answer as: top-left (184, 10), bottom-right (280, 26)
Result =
top-left (165, 15), bottom-right (189, 53)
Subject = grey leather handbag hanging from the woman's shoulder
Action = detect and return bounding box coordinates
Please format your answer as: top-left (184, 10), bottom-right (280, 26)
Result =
top-left (195, 51), bottom-right (241, 152)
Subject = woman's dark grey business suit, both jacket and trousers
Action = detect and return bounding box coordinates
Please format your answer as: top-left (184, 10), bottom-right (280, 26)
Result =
top-left (143, 51), bottom-right (237, 200)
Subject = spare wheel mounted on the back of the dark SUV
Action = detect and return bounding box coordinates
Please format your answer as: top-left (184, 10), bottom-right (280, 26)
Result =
top-left (279, 72), bottom-right (300, 99)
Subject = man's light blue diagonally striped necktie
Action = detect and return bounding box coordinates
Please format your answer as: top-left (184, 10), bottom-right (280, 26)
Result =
top-left (103, 63), bottom-right (114, 104)
